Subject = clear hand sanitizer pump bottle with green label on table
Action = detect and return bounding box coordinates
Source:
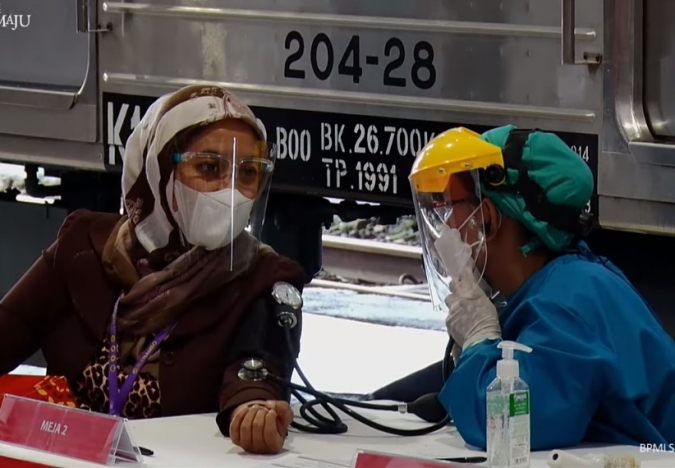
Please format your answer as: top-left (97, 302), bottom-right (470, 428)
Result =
top-left (486, 341), bottom-right (532, 468)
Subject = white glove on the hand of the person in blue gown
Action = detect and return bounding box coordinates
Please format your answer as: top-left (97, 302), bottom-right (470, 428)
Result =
top-left (445, 266), bottom-right (502, 350)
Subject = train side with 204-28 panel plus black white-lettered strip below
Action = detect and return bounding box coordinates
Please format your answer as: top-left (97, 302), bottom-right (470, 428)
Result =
top-left (100, 0), bottom-right (602, 205)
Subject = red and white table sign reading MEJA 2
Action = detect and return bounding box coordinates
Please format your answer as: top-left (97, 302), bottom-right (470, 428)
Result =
top-left (0, 395), bottom-right (143, 466)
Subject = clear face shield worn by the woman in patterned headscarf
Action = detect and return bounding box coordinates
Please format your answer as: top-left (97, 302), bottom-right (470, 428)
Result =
top-left (173, 138), bottom-right (276, 269)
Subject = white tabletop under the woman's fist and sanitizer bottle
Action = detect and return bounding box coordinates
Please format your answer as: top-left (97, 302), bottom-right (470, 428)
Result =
top-left (0, 402), bottom-right (675, 468)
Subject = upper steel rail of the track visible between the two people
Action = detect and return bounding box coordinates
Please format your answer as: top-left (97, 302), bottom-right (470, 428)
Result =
top-left (323, 235), bottom-right (426, 285)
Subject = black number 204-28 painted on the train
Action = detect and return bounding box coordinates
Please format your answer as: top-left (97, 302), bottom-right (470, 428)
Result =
top-left (284, 31), bottom-right (436, 89)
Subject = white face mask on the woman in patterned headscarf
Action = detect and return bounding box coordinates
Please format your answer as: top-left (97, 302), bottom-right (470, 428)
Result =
top-left (172, 181), bottom-right (254, 250)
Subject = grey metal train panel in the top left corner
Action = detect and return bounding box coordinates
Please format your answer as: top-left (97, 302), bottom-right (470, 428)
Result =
top-left (0, 0), bottom-right (99, 157)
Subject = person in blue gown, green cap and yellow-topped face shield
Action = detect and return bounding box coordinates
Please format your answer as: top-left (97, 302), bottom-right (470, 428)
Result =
top-left (410, 126), bottom-right (675, 450)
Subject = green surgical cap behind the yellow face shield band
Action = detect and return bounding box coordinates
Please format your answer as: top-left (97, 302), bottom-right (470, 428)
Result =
top-left (481, 125), bottom-right (593, 255)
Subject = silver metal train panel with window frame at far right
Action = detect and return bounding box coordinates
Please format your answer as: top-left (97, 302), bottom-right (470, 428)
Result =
top-left (598, 0), bottom-right (675, 234)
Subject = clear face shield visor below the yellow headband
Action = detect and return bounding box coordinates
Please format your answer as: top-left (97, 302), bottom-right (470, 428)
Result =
top-left (413, 171), bottom-right (493, 313)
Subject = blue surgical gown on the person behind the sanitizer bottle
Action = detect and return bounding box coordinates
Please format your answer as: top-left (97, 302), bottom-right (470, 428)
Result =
top-left (439, 243), bottom-right (675, 450)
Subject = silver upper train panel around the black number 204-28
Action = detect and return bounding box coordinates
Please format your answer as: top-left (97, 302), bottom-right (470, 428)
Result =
top-left (101, 0), bottom-right (602, 133)
